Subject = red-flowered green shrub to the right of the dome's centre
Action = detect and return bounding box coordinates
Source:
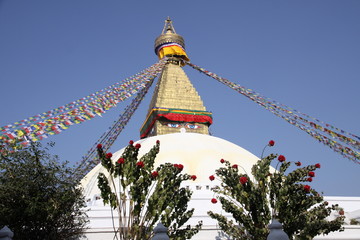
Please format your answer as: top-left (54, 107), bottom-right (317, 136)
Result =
top-left (208, 150), bottom-right (344, 240)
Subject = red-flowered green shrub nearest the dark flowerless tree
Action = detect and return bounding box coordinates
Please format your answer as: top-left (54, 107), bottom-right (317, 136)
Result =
top-left (98, 141), bottom-right (202, 240)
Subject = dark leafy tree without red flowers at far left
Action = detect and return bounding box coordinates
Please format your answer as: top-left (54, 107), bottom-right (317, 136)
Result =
top-left (0, 143), bottom-right (86, 240)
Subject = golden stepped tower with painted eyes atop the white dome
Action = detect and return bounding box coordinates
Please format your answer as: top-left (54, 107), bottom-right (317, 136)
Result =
top-left (140, 18), bottom-right (212, 138)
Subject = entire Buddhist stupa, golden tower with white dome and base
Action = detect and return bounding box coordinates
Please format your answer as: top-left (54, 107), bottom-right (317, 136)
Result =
top-left (81, 18), bottom-right (360, 240)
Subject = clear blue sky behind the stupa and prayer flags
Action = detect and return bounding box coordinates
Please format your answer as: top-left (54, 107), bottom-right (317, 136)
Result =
top-left (0, 0), bottom-right (360, 197)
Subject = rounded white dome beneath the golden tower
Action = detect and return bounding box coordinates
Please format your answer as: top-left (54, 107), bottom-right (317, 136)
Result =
top-left (81, 133), bottom-right (259, 199)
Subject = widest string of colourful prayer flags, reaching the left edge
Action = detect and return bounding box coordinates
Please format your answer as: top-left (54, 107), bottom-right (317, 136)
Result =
top-left (0, 59), bottom-right (166, 145)
